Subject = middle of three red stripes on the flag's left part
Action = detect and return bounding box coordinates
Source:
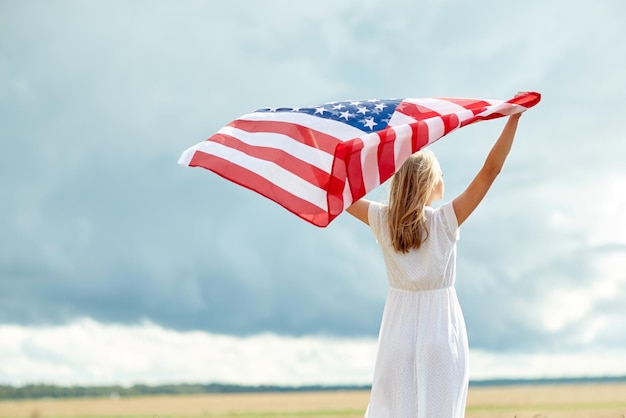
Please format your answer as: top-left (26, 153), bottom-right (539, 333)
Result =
top-left (207, 133), bottom-right (330, 189)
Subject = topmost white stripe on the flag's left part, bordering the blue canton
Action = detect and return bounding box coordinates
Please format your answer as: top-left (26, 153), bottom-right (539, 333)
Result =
top-left (239, 112), bottom-right (367, 141)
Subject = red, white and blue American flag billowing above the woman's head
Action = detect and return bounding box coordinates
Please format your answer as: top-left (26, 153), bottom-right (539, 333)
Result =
top-left (178, 92), bottom-right (541, 227)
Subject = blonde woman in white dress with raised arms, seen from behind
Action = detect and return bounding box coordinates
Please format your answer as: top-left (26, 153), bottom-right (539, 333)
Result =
top-left (348, 113), bottom-right (521, 418)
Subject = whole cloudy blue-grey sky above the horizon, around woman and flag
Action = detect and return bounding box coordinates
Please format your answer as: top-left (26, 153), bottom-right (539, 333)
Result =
top-left (0, 0), bottom-right (626, 385)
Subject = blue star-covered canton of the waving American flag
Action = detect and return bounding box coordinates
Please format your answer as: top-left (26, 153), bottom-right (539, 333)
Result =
top-left (257, 99), bottom-right (402, 132)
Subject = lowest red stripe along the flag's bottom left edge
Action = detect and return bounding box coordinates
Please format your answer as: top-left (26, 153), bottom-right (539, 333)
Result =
top-left (189, 151), bottom-right (330, 227)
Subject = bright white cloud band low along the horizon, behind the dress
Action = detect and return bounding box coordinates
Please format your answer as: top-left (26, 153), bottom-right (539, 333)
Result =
top-left (0, 319), bottom-right (626, 385)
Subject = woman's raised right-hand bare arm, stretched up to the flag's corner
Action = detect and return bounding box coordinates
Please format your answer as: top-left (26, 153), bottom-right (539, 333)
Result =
top-left (452, 113), bottom-right (521, 226)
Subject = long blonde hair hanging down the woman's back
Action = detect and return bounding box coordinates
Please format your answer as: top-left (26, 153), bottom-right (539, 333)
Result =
top-left (389, 150), bottom-right (441, 253)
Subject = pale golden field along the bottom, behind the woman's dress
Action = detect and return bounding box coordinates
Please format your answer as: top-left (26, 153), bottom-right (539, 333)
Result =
top-left (0, 384), bottom-right (626, 418)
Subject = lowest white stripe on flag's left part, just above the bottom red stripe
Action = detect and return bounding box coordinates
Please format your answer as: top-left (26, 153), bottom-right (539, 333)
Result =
top-left (190, 141), bottom-right (328, 211)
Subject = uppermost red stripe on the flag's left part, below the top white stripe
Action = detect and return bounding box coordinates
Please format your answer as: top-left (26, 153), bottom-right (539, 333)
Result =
top-left (228, 119), bottom-right (341, 155)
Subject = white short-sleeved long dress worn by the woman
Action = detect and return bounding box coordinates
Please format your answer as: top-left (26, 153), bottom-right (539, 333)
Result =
top-left (365, 202), bottom-right (469, 418)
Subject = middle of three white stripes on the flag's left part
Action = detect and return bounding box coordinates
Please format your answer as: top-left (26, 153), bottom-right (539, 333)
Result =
top-left (218, 126), bottom-right (333, 173)
